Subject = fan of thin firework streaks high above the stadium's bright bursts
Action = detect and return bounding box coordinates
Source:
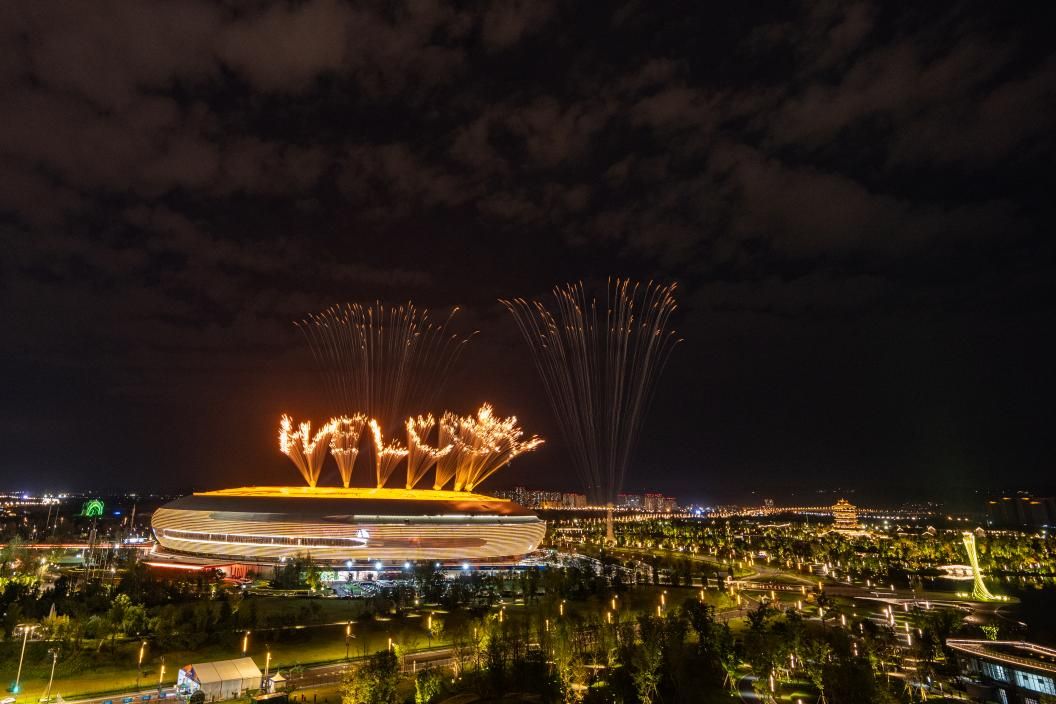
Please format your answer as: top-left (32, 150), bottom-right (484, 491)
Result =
top-left (297, 302), bottom-right (475, 430)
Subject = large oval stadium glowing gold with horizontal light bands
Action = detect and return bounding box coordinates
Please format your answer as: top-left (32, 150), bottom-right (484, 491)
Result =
top-left (149, 487), bottom-right (546, 575)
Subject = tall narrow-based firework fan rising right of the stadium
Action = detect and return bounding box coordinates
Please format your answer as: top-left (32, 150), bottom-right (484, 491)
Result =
top-left (501, 279), bottom-right (680, 515)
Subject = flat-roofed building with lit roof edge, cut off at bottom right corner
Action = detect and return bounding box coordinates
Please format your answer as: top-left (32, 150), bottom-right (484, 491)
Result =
top-left (946, 639), bottom-right (1056, 704)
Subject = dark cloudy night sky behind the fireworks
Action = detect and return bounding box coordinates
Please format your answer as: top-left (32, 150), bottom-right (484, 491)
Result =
top-left (0, 0), bottom-right (1056, 500)
